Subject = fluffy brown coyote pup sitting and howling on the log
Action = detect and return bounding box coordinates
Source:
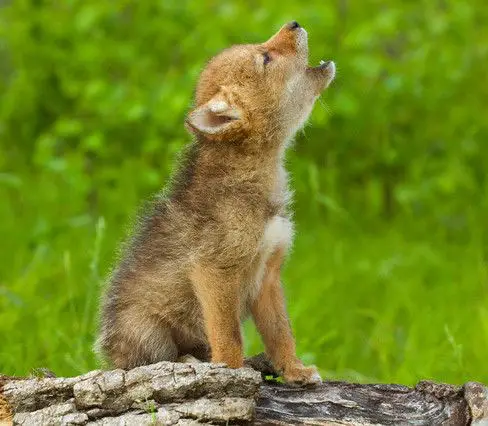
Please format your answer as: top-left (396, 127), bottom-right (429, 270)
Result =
top-left (97, 22), bottom-right (335, 383)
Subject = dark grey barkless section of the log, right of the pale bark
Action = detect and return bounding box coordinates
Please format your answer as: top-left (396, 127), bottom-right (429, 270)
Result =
top-left (256, 382), bottom-right (470, 425)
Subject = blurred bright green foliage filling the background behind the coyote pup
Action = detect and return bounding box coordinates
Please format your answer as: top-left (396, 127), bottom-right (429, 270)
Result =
top-left (0, 0), bottom-right (488, 382)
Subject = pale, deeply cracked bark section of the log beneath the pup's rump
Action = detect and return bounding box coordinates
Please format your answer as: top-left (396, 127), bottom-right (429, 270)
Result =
top-left (1, 362), bottom-right (261, 425)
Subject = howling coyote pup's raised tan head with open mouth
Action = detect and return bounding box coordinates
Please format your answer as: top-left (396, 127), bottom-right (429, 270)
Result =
top-left (186, 21), bottom-right (335, 145)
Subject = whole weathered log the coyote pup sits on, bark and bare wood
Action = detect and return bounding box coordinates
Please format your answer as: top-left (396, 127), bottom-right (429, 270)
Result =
top-left (0, 359), bottom-right (488, 426)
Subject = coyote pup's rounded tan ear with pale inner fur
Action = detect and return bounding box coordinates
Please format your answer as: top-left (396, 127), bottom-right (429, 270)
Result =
top-left (186, 92), bottom-right (242, 136)
